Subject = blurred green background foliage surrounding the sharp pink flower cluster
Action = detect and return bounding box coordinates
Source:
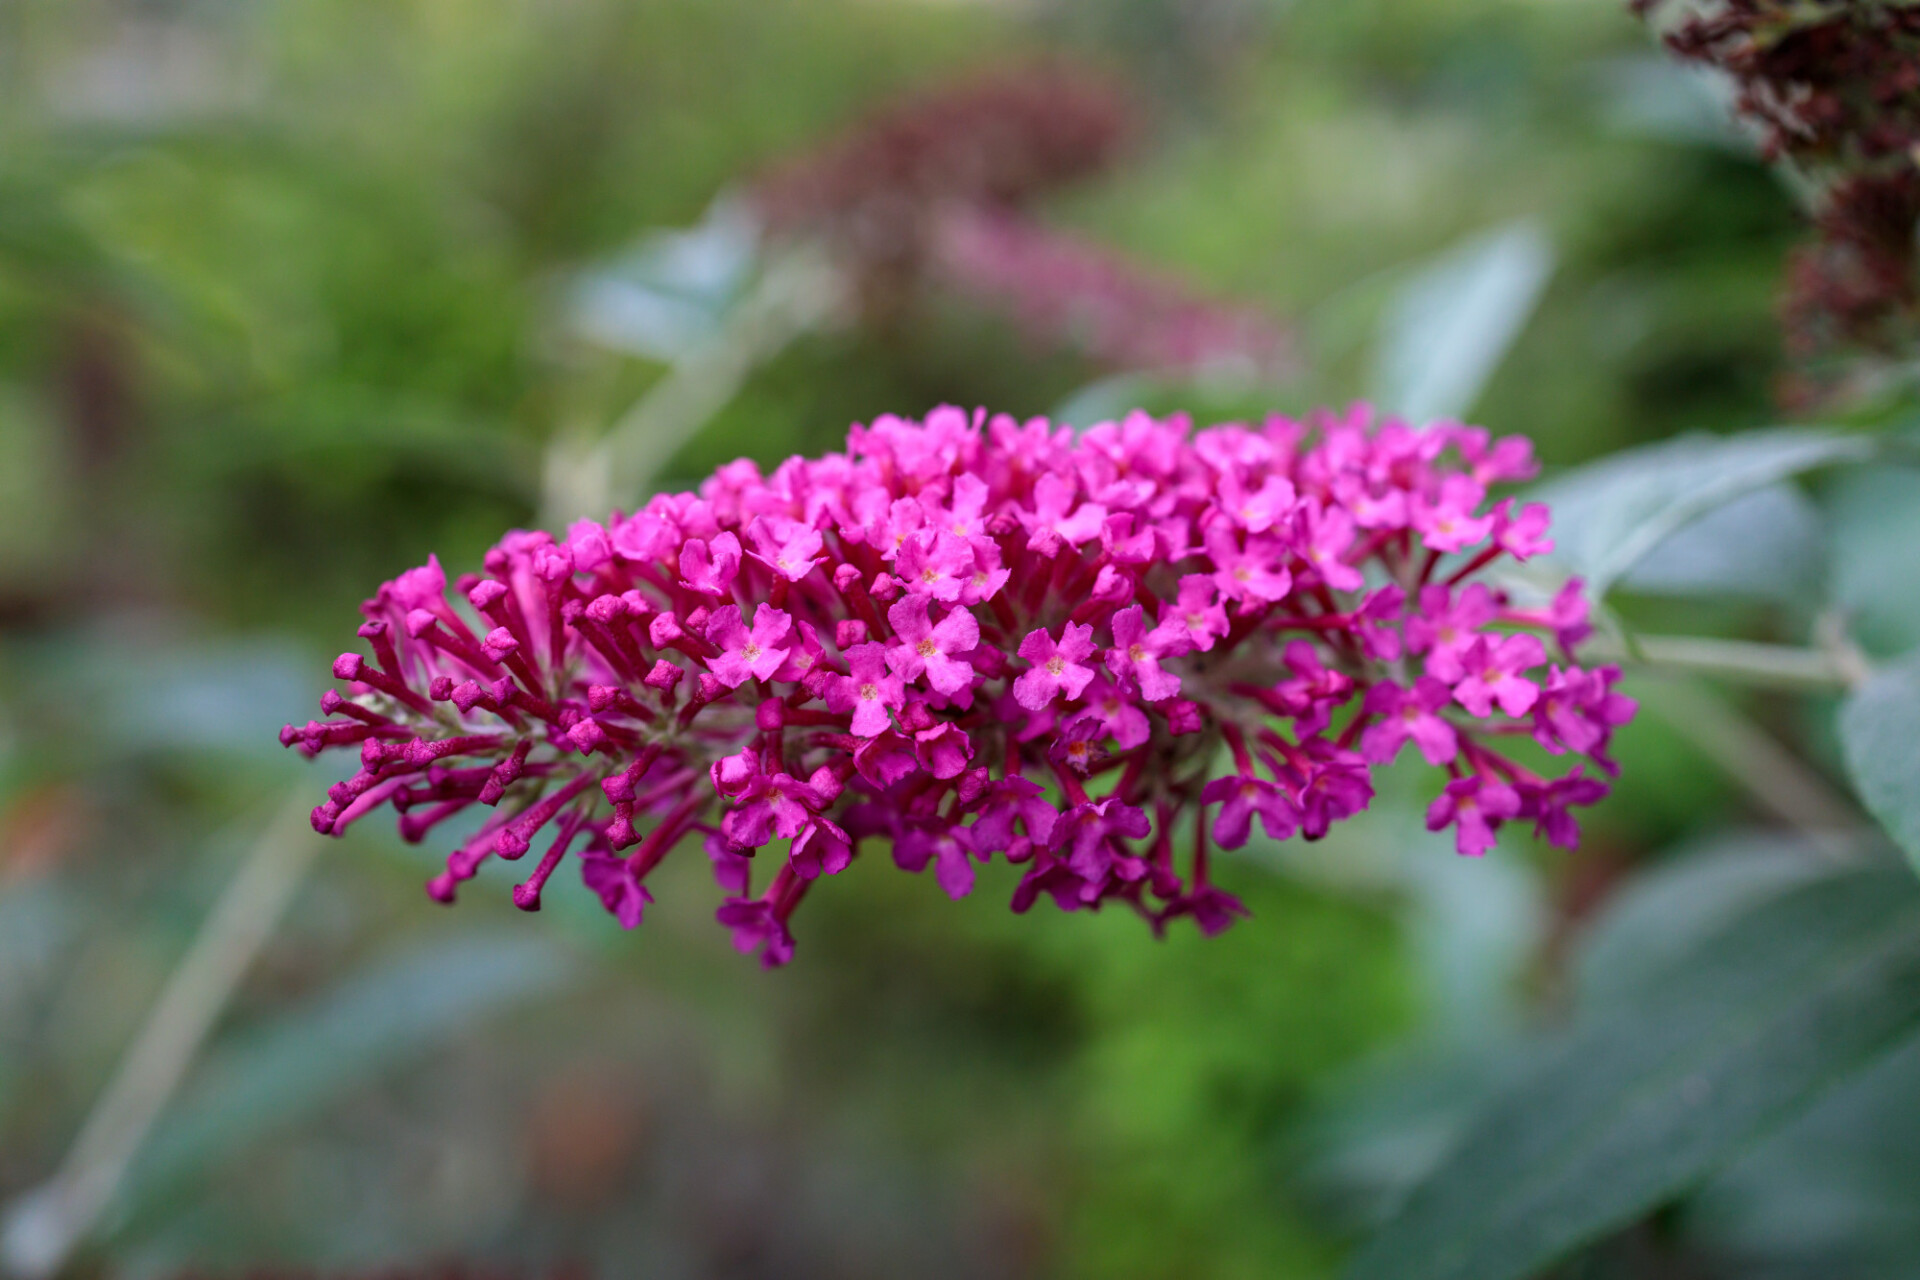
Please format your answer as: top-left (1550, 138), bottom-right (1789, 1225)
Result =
top-left (0, 0), bottom-right (1889, 1276)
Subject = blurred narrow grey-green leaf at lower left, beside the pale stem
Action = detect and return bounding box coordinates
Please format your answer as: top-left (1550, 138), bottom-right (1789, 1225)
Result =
top-left (121, 931), bottom-right (572, 1207)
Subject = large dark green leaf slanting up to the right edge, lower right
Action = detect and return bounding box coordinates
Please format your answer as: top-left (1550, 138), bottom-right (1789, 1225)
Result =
top-left (1350, 869), bottom-right (1920, 1280)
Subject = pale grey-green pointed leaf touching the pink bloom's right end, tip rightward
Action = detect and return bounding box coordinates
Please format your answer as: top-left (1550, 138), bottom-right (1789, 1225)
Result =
top-left (1528, 426), bottom-right (1880, 599)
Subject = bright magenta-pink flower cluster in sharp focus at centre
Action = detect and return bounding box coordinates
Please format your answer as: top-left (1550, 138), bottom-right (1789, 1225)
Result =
top-left (282, 407), bottom-right (1634, 965)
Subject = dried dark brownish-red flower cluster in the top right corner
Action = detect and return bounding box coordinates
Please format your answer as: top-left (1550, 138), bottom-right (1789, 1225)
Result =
top-left (1634, 0), bottom-right (1920, 355)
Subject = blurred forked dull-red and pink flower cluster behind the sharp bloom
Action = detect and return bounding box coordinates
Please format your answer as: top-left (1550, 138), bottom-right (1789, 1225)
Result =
top-left (751, 61), bottom-right (1294, 376)
